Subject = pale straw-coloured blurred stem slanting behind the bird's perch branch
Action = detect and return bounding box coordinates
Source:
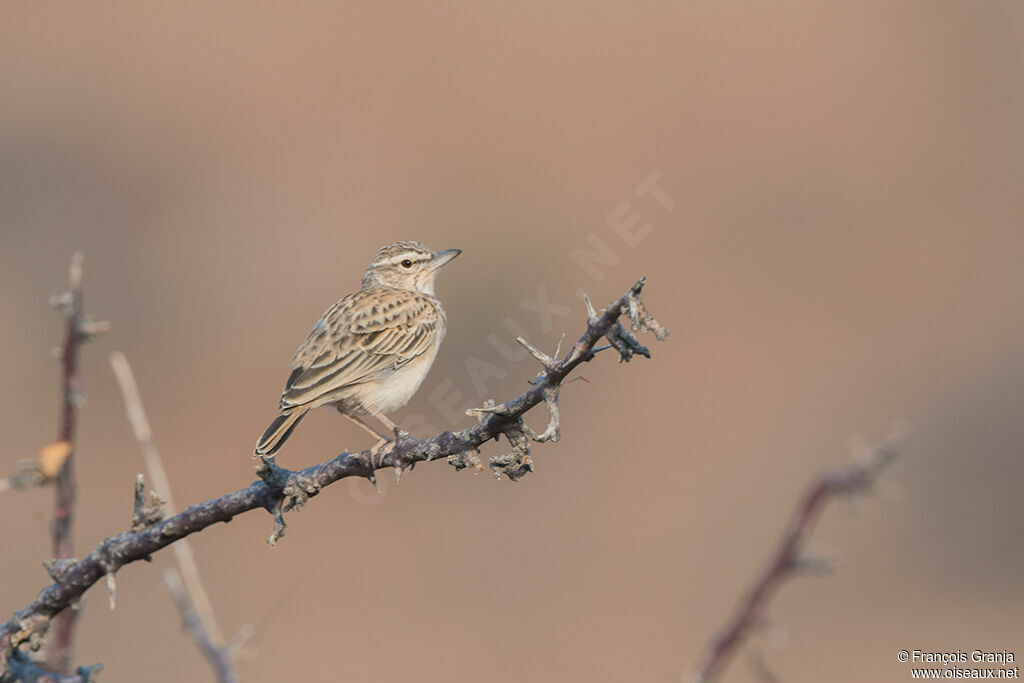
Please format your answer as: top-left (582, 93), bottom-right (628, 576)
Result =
top-left (110, 351), bottom-right (252, 683)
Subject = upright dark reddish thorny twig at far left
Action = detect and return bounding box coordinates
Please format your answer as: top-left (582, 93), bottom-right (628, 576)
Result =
top-left (46, 252), bottom-right (110, 674)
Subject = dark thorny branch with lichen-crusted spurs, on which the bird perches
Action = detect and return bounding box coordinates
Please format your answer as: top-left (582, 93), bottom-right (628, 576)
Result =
top-left (0, 279), bottom-right (669, 670)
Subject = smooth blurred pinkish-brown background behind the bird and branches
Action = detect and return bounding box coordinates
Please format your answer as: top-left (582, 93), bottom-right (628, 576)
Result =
top-left (0, 1), bottom-right (1024, 683)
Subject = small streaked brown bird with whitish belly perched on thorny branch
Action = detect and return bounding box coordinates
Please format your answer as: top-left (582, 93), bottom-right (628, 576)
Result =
top-left (254, 242), bottom-right (461, 457)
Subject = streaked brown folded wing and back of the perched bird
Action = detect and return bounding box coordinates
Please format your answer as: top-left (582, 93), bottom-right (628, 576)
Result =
top-left (281, 288), bottom-right (443, 409)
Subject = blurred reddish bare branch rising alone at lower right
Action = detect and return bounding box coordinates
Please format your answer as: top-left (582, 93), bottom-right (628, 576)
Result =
top-left (694, 423), bottom-right (907, 683)
